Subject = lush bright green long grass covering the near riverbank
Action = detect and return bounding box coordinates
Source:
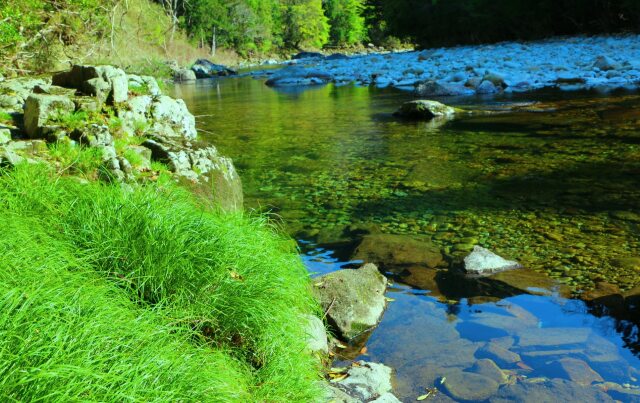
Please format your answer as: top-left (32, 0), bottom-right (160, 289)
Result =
top-left (0, 166), bottom-right (319, 402)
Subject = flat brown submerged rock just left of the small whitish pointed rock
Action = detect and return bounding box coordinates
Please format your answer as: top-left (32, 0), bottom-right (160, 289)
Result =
top-left (353, 234), bottom-right (444, 269)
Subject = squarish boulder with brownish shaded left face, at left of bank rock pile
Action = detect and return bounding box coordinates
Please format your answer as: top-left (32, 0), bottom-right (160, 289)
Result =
top-left (24, 94), bottom-right (75, 138)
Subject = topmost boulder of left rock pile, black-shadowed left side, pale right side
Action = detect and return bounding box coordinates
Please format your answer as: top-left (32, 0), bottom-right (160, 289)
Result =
top-left (52, 65), bottom-right (129, 104)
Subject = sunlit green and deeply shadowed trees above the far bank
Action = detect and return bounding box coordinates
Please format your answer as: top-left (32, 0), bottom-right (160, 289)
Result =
top-left (169, 0), bottom-right (640, 52)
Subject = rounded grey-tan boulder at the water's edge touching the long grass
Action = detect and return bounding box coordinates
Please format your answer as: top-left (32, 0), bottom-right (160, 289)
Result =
top-left (313, 264), bottom-right (387, 339)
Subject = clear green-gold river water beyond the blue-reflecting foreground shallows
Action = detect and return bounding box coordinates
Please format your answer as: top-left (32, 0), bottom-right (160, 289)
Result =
top-left (174, 78), bottom-right (640, 290)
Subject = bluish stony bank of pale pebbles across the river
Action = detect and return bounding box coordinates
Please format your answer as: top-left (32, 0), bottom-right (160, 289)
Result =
top-left (252, 35), bottom-right (640, 97)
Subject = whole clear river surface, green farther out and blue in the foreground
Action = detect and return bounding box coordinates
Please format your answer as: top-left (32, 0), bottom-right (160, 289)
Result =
top-left (174, 78), bottom-right (640, 401)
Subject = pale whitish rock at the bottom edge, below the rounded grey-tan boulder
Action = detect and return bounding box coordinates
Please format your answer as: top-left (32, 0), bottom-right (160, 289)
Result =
top-left (331, 361), bottom-right (398, 402)
